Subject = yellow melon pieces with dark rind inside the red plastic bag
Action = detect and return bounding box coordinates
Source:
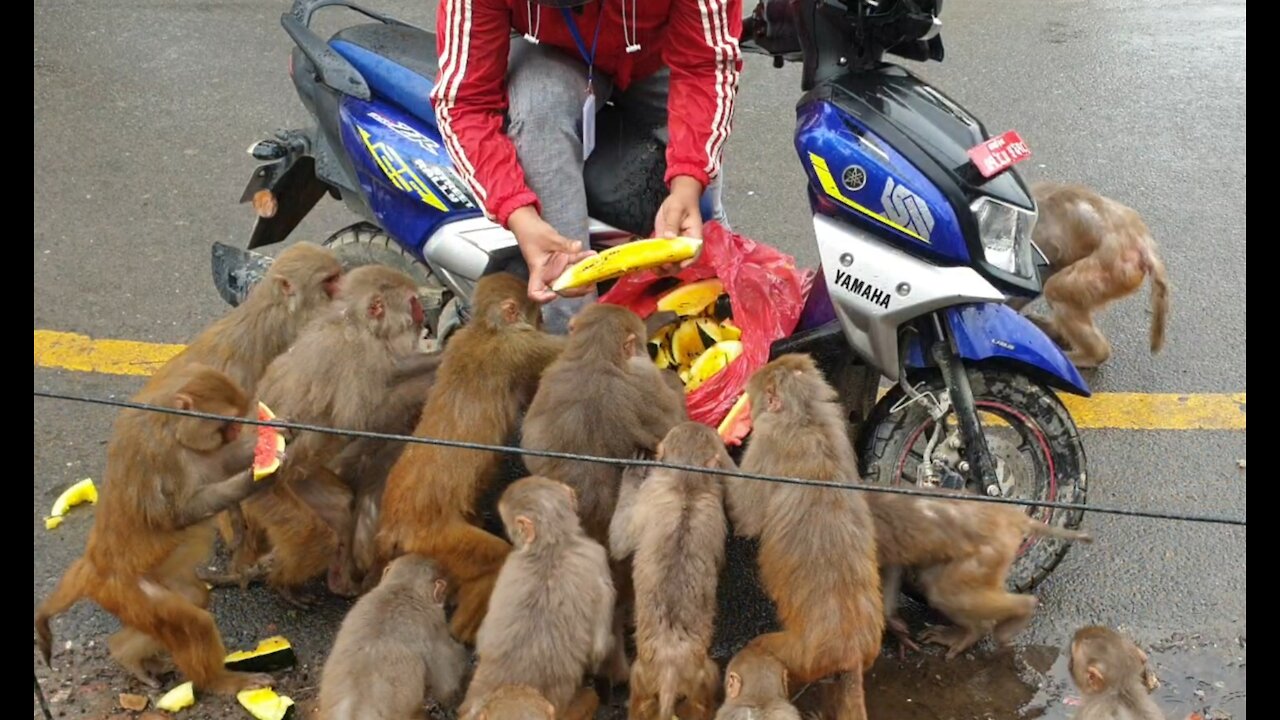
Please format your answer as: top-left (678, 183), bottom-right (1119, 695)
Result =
top-left (648, 278), bottom-right (742, 392)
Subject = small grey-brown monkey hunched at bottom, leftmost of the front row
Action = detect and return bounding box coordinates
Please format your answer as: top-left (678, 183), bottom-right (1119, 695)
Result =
top-left (320, 555), bottom-right (467, 720)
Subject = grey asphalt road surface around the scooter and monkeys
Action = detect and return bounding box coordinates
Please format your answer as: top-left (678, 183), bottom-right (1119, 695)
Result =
top-left (32, 0), bottom-right (1245, 719)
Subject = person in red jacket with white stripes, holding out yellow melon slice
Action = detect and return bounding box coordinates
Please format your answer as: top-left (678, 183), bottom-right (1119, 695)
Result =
top-left (431, 0), bottom-right (742, 332)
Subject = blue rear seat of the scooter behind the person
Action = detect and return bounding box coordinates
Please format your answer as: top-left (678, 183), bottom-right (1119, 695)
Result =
top-left (329, 23), bottom-right (439, 127)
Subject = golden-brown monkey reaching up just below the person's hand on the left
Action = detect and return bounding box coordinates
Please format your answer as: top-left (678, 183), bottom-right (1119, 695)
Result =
top-left (375, 273), bottom-right (563, 644)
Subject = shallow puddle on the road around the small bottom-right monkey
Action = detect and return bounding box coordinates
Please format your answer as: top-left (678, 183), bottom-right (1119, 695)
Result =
top-left (834, 641), bottom-right (1245, 720)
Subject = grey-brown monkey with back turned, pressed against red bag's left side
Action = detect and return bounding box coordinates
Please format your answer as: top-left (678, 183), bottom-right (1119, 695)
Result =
top-left (520, 304), bottom-right (687, 683)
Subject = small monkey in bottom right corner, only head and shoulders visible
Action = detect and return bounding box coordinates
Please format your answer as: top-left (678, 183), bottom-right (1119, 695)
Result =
top-left (1069, 625), bottom-right (1165, 720)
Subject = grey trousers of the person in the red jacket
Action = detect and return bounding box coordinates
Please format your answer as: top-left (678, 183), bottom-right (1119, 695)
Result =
top-left (507, 38), bottom-right (728, 334)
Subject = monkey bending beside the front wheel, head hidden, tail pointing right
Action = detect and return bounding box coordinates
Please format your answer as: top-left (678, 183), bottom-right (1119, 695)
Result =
top-left (867, 493), bottom-right (1093, 660)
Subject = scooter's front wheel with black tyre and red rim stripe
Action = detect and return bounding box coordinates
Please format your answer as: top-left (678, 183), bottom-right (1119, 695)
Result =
top-left (859, 366), bottom-right (1087, 592)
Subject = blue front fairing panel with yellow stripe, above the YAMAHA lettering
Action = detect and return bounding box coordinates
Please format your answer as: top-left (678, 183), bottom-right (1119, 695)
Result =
top-left (795, 100), bottom-right (969, 264)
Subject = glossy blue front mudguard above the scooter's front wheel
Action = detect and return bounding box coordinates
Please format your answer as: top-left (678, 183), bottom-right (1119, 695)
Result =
top-left (906, 302), bottom-right (1092, 397)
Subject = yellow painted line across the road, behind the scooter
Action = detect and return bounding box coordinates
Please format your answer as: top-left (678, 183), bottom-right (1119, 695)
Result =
top-left (36, 331), bottom-right (1245, 430)
